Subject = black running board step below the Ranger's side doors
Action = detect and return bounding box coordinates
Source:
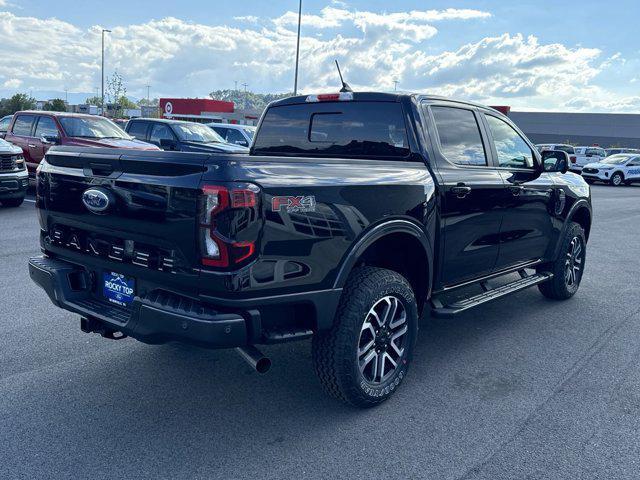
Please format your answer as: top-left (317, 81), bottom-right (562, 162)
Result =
top-left (431, 270), bottom-right (553, 317)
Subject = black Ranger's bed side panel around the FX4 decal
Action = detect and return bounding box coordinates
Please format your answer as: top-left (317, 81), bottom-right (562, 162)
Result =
top-left (201, 156), bottom-right (434, 298)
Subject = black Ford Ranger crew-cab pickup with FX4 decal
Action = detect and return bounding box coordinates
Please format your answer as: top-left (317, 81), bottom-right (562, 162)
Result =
top-left (29, 92), bottom-right (592, 406)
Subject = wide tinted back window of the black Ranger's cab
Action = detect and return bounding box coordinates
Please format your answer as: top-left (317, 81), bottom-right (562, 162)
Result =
top-left (254, 102), bottom-right (410, 160)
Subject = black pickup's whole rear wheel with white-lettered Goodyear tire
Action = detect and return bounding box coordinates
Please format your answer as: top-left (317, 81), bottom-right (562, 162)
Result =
top-left (312, 267), bottom-right (418, 407)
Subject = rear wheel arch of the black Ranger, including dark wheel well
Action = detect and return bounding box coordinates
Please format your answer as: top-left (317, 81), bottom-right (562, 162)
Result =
top-left (334, 219), bottom-right (433, 310)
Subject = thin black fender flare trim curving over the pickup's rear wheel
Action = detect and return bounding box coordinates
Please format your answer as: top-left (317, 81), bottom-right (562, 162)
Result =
top-left (334, 219), bottom-right (433, 295)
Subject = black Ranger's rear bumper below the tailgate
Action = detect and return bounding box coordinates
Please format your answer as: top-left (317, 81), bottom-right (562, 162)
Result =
top-left (29, 256), bottom-right (341, 348)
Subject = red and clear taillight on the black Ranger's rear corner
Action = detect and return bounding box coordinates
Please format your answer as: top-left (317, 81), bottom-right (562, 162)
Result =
top-left (200, 184), bottom-right (262, 268)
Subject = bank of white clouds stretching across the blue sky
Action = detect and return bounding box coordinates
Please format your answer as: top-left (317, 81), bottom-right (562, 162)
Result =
top-left (0, 9), bottom-right (640, 111)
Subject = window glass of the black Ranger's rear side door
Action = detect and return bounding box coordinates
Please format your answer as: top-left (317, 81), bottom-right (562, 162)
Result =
top-left (431, 107), bottom-right (487, 166)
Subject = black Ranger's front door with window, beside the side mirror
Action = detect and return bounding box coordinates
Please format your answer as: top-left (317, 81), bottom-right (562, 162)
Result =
top-left (484, 113), bottom-right (564, 269)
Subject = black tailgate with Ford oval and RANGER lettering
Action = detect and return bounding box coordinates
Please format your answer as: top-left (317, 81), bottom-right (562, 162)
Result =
top-left (37, 147), bottom-right (208, 294)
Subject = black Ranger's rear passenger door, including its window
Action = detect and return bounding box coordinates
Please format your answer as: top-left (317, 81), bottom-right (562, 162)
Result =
top-left (428, 103), bottom-right (504, 288)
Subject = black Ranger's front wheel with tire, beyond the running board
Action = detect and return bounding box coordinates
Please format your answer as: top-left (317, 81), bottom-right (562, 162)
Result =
top-left (538, 222), bottom-right (587, 300)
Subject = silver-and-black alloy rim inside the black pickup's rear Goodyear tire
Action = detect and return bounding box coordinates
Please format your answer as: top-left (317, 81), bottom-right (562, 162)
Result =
top-left (358, 296), bottom-right (408, 384)
